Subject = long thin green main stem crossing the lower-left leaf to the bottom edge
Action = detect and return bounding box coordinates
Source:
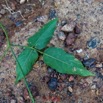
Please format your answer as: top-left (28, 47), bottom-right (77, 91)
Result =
top-left (0, 23), bottom-right (35, 103)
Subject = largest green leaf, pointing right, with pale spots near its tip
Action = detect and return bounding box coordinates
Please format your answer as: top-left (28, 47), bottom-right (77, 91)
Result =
top-left (43, 47), bottom-right (94, 76)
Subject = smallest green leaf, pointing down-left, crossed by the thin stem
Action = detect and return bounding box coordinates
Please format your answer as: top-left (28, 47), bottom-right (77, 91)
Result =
top-left (16, 48), bottom-right (38, 83)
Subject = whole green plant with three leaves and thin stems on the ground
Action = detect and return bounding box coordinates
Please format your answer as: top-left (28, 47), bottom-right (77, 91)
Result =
top-left (0, 19), bottom-right (94, 103)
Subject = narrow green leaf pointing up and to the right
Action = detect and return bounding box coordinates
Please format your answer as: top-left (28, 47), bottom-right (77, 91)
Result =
top-left (28, 19), bottom-right (58, 50)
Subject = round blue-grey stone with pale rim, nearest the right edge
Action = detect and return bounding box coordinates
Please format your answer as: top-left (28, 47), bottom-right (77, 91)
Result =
top-left (87, 37), bottom-right (100, 49)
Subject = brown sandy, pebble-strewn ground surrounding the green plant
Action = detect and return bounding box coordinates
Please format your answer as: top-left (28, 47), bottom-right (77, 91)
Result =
top-left (0, 0), bottom-right (103, 103)
